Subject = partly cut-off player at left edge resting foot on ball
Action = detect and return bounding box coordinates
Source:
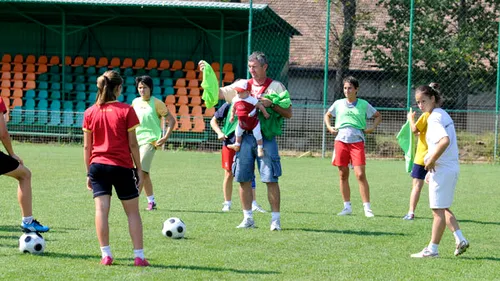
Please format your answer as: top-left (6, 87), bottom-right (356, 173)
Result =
top-left (0, 99), bottom-right (50, 232)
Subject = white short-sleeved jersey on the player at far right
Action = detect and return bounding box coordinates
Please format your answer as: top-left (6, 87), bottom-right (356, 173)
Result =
top-left (424, 108), bottom-right (460, 171)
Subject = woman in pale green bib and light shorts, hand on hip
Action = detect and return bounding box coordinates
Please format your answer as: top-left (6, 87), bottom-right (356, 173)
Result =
top-left (132, 75), bottom-right (176, 211)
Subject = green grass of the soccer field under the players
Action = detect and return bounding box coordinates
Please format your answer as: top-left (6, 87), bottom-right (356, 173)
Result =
top-left (0, 143), bottom-right (500, 280)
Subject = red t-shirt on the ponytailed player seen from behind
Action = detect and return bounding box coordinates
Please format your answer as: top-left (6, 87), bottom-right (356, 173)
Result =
top-left (83, 102), bottom-right (139, 168)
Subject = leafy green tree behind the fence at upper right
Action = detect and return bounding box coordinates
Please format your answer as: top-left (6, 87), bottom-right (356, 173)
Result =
top-left (359, 0), bottom-right (500, 114)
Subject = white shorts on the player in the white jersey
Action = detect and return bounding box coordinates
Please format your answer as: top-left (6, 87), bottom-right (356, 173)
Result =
top-left (428, 170), bottom-right (458, 209)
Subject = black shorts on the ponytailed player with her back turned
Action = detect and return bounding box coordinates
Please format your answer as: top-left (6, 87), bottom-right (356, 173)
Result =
top-left (88, 163), bottom-right (139, 200)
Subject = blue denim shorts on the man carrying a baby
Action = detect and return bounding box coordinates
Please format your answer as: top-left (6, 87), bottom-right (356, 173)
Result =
top-left (232, 132), bottom-right (281, 183)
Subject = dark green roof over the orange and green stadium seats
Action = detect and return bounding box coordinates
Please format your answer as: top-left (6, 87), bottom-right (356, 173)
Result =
top-left (0, 0), bottom-right (300, 37)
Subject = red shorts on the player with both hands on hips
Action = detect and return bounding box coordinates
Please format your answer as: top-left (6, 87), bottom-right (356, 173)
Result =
top-left (332, 141), bottom-right (366, 167)
